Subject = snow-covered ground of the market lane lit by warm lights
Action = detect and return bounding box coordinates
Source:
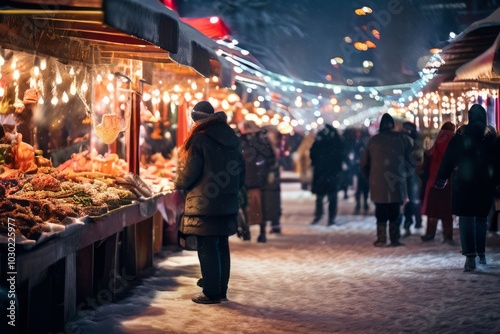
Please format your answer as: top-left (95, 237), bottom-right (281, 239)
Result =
top-left (67, 183), bottom-right (500, 334)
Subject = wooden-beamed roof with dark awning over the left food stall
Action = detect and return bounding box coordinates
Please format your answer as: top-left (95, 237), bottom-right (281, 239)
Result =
top-left (0, 0), bottom-right (221, 77)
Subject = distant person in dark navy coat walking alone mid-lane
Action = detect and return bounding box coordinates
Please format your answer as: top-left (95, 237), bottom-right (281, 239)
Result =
top-left (310, 124), bottom-right (345, 226)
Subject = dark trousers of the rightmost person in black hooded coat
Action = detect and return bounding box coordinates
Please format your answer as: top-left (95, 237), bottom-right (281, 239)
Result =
top-left (458, 216), bottom-right (488, 257)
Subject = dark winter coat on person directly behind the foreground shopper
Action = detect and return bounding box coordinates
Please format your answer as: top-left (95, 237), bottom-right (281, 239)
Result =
top-left (240, 130), bottom-right (276, 189)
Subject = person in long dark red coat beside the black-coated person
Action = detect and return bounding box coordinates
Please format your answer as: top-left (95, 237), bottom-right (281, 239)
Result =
top-left (421, 122), bottom-right (455, 244)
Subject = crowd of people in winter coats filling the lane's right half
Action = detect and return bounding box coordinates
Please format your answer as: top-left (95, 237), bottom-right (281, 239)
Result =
top-left (298, 104), bottom-right (500, 271)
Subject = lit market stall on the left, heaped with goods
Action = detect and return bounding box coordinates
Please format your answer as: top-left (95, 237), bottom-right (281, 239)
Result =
top-left (0, 1), bottom-right (229, 333)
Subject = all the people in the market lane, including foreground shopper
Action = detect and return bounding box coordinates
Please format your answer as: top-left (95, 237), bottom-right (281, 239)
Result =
top-left (175, 101), bottom-right (500, 304)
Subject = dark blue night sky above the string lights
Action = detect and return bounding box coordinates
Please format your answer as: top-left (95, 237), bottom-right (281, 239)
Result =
top-left (177, 0), bottom-right (468, 86)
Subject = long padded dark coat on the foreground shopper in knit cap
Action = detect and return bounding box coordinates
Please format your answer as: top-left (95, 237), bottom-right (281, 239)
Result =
top-left (174, 112), bottom-right (245, 236)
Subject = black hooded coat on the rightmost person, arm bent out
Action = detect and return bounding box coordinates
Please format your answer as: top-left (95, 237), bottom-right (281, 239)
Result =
top-left (435, 104), bottom-right (496, 217)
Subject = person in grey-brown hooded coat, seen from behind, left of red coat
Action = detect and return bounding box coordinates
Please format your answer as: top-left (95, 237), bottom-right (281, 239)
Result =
top-left (360, 113), bottom-right (414, 247)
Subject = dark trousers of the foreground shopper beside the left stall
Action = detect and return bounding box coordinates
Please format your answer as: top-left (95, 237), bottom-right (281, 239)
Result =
top-left (196, 236), bottom-right (231, 299)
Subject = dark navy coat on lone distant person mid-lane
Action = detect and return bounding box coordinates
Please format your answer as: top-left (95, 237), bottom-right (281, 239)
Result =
top-left (310, 125), bottom-right (346, 194)
